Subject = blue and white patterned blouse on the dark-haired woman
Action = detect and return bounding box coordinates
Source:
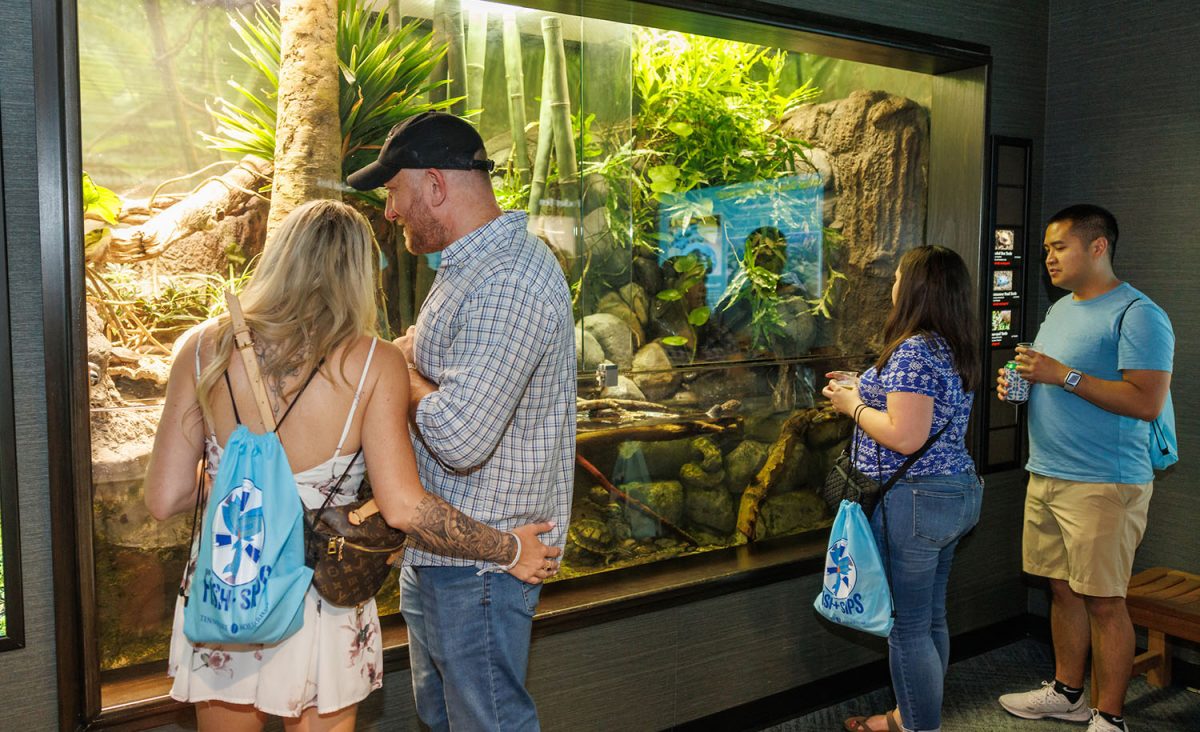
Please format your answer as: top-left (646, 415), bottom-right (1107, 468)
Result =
top-left (854, 335), bottom-right (974, 480)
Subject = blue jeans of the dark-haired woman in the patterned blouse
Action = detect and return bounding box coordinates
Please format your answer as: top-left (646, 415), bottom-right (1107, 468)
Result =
top-left (871, 473), bottom-right (983, 732)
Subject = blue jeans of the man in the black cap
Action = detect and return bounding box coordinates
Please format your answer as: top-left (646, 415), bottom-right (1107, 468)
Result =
top-left (400, 566), bottom-right (541, 732)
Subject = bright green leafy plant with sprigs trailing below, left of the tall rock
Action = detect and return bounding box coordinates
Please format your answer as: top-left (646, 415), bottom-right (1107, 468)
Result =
top-left (588, 29), bottom-right (820, 354)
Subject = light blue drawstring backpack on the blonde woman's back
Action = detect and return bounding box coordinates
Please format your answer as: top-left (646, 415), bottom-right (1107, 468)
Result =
top-left (184, 293), bottom-right (317, 643)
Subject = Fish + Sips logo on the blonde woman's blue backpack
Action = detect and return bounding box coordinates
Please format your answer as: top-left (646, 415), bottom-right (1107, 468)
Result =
top-left (203, 479), bottom-right (271, 632)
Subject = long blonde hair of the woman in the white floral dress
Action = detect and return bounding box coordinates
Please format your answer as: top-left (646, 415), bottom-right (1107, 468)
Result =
top-left (196, 200), bottom-right (378, 422)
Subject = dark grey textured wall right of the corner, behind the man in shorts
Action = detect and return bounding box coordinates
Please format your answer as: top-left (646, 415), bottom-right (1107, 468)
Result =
top-left (1043, 0), bottom-right (1200, 571)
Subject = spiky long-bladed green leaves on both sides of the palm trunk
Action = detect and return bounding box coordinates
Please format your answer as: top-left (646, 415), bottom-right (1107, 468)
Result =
top-left (204, 0), bottom-right (457, 174)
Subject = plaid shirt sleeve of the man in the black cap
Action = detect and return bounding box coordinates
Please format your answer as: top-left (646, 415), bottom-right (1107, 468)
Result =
top-left (415, 275), bottom-right (552, 472)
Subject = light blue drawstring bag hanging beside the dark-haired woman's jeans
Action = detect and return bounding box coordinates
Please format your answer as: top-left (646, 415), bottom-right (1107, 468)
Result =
top-left (812, 500), bottom-right (893, 637)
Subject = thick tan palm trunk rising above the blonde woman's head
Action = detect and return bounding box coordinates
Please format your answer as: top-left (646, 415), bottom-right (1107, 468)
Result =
top-left (266, 0), bottom-right (342, 240)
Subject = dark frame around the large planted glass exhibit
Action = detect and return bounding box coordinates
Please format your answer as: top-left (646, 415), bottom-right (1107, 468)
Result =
top-left (32, 0), bottom-right (991, 730)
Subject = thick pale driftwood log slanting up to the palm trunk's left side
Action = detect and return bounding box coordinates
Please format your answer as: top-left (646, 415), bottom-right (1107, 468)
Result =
top-left (106, 156), bottom-right (272, 262)
